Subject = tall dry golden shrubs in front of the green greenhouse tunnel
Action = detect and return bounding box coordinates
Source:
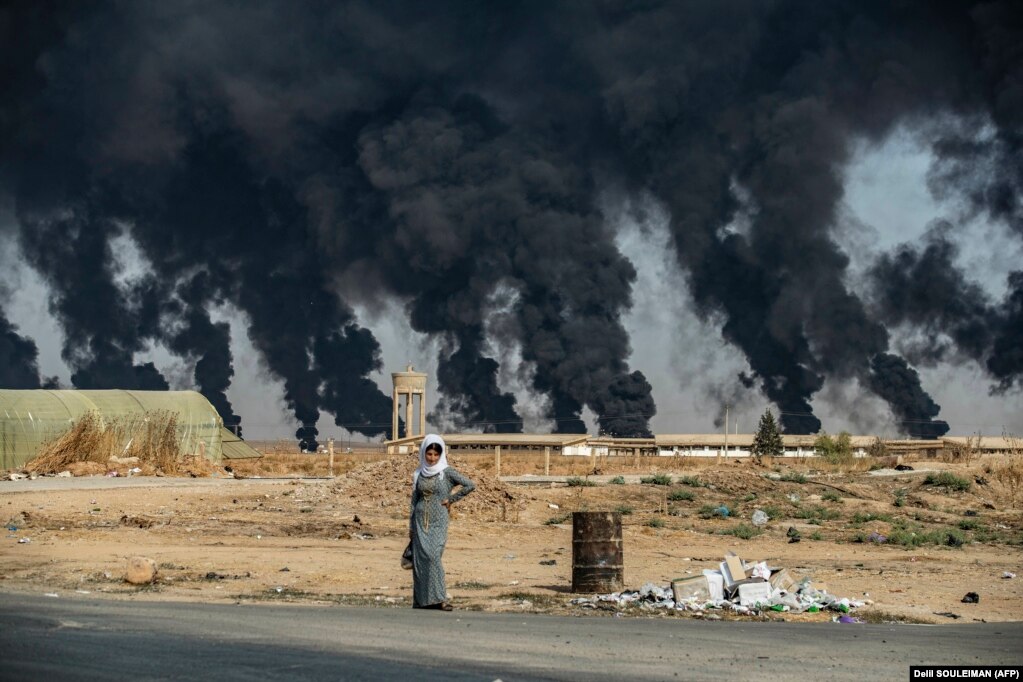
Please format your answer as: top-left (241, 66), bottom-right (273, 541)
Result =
top-left (25, 411), bottom-right (191, 475)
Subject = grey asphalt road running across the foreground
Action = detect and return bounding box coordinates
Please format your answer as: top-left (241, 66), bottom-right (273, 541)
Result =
top-left (0, 594), bottom-right (1023, 682)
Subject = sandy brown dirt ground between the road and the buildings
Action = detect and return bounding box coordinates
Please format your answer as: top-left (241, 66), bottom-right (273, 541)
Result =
top-left (0, 454), bottom-right (1023, 623)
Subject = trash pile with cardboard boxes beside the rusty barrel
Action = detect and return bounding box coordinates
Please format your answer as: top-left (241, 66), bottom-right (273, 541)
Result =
top-left (570, 552), bottom-right (870, 623)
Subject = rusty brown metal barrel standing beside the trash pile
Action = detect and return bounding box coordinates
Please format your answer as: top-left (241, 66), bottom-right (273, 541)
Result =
top-left (572, 511), bottom-right (625, 592)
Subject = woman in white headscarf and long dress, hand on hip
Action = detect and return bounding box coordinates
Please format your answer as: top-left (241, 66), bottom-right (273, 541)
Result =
top-left (408, 434), bottom-right (476, 611)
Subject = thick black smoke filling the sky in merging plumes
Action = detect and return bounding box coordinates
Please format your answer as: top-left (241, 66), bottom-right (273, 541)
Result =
top-left (0, 0), bottom-right (1023, 437)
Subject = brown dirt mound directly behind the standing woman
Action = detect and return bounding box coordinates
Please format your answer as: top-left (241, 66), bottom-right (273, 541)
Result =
top-left (332, 455), bottom-right (518, 520)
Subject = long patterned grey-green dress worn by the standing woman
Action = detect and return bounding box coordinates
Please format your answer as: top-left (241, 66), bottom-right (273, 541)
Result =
top-left (408, 466), bottom-right (476, 607)
